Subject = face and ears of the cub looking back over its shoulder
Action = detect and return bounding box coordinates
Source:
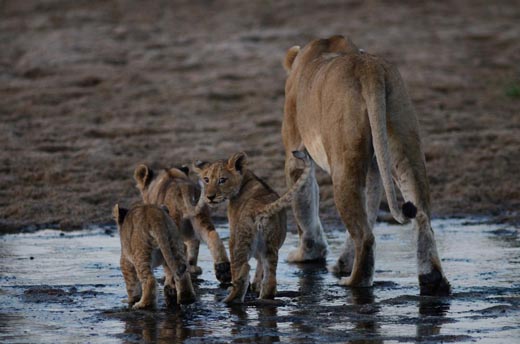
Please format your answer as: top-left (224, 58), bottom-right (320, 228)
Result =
top-left (193, 152), bottom-right (247, 206)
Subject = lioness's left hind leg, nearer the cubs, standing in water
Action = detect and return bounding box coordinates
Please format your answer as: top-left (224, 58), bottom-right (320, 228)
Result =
top-left (332, 162), bottom-right (375, 287)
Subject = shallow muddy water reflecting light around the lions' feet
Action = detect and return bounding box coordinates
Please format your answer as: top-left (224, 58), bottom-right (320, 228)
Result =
top-left (0, 220), bottom-right (520, 343)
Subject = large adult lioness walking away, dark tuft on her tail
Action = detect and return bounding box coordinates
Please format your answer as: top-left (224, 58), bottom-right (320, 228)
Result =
top-left (282, 36), bottom-right (450, 295)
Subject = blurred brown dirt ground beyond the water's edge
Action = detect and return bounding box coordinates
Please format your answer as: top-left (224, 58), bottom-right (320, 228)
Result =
top-left (0, 0), bottom-right (520, 232)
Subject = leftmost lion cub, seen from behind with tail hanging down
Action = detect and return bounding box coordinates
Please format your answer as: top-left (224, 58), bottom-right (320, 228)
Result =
top-left (113, 204), bottom-right (195, 309)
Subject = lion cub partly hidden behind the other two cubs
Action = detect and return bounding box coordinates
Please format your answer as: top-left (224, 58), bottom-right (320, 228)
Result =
top-left (134, 165), bottom-right (231, 282)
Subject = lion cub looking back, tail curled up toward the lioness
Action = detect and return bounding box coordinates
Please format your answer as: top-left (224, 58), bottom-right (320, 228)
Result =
top-left (194, 151), bottom-right (311, 303)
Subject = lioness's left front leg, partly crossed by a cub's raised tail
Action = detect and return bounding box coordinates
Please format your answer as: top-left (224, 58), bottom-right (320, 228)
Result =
top-left (285, 153), bottom-right (328, 263)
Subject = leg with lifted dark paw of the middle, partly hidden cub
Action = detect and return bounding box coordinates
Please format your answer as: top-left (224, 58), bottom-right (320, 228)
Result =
top-left (192, 214), bottom-right (231, 283)
